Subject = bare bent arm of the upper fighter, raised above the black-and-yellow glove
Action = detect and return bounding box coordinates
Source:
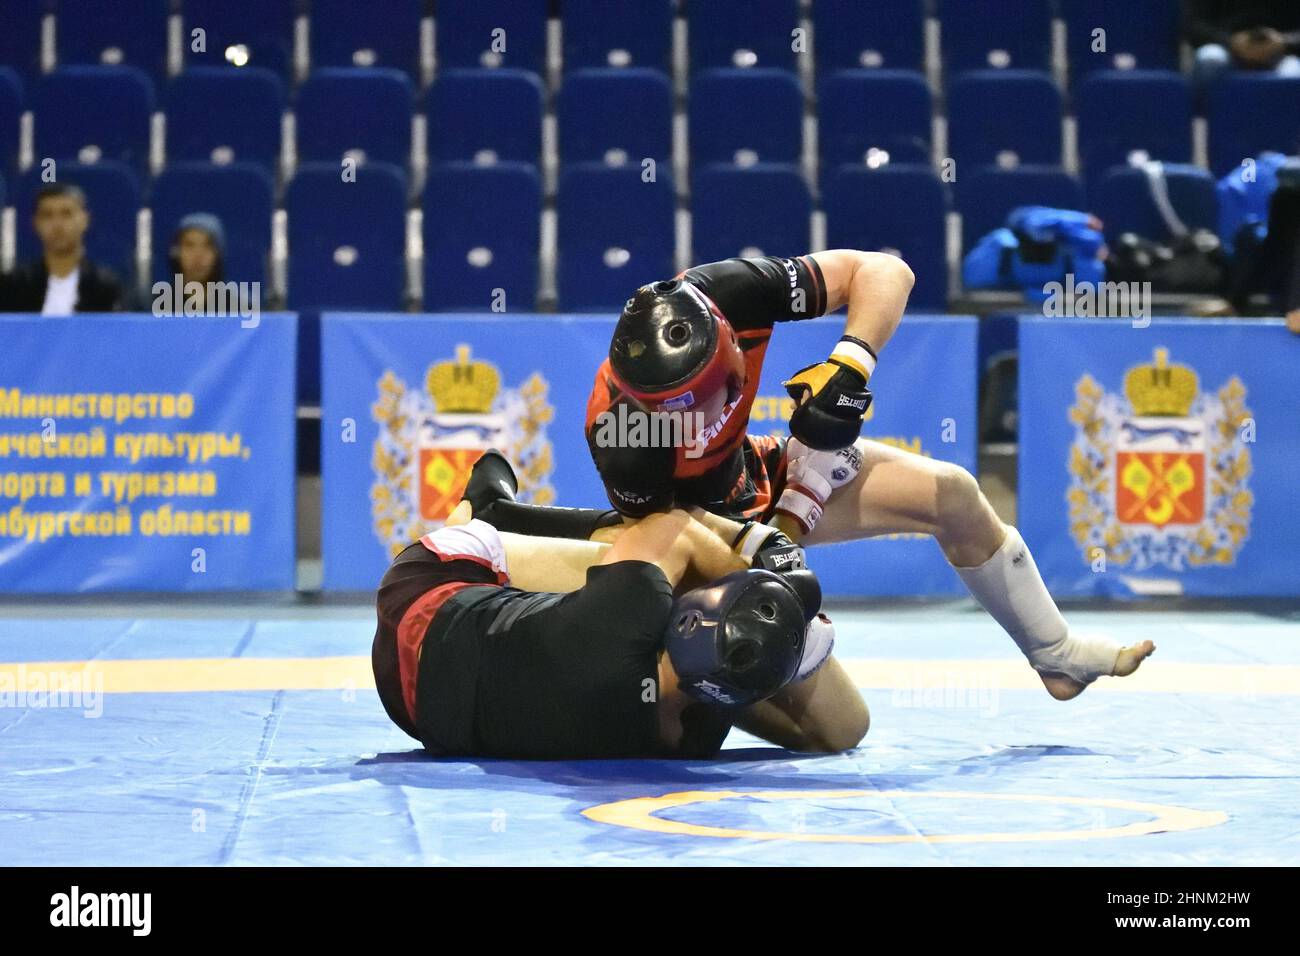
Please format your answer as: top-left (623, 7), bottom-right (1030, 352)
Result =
top-left (813, 248), bottom-right (915, 364)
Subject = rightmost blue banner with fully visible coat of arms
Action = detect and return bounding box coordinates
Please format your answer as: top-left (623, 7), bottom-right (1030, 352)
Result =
top-left (1019, 317), bottom-right (1300, 597)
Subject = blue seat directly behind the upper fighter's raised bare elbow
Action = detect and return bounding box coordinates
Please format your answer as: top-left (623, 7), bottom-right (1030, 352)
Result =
top-left (823, 165), bottom-right (948, 310)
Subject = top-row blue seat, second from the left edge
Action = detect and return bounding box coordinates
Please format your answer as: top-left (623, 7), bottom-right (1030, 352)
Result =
top-left (55, 0), bottom-right (170, 83)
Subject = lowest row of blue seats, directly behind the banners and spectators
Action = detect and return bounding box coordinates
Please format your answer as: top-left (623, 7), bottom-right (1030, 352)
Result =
top-left (0, 161), bottom-right (1217, 311)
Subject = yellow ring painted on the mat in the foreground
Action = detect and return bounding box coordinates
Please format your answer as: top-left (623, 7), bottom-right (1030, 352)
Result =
top-left (582, 790), bottom-right (1227, 843)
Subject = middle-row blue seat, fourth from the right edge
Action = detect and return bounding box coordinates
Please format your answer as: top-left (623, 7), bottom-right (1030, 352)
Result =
top-left (818, 70), bottom-right (931, 166)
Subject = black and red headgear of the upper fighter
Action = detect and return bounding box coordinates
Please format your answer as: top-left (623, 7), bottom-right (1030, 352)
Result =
top-left (610, 278), bottom-right (745, 411)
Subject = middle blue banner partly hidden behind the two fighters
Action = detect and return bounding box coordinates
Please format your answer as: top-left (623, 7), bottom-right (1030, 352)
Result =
top-left (321, 313), bottom-right (976, 594)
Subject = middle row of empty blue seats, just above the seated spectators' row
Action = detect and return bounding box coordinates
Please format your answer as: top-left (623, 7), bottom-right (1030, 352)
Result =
top-left (10, 66), bottom-right (1300, 184)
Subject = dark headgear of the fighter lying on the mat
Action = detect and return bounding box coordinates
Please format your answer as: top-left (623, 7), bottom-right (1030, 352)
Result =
top-left (664, 568), bottom-right (822, 708)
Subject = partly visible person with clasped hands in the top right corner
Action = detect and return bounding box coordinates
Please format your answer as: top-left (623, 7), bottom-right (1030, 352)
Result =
top-left (1183, 0), bottom-right (1300, 87)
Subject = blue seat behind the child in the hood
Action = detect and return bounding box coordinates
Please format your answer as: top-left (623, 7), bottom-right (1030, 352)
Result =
top-left (150, 163), bottom-right (274, 286)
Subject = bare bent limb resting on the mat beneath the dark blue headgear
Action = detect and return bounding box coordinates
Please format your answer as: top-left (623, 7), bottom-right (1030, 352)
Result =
top-left (735, 657), bottom-right (871, 753)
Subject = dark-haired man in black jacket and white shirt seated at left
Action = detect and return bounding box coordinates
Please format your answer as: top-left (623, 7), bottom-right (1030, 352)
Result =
top-left (0, 183), bottom-right (125, 317)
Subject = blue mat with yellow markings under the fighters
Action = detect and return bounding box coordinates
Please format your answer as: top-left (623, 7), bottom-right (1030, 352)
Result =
top-left (0, 602), bottom-right (1300, 866)
